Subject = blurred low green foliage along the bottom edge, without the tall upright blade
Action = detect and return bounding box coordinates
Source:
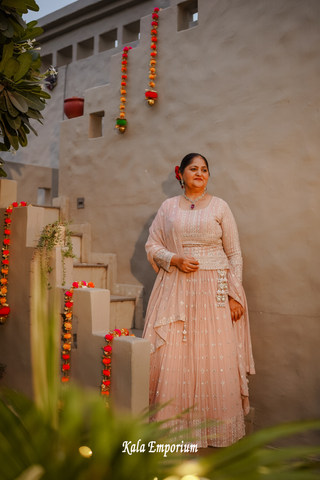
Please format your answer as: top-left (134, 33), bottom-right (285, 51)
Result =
top-left (0, 387), bottom-right (320, 480)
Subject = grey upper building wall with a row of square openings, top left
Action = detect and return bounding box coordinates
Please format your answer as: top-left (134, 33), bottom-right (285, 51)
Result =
top-left (2, 0), bottom-right (169, 172)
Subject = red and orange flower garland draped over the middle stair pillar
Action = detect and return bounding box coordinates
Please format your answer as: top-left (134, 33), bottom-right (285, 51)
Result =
top-left (61, 281), bottom-right (94, 383)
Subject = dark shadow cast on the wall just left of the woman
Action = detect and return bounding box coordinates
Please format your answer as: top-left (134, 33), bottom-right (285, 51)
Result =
top-left (130, 172), bottom-right (179, 315)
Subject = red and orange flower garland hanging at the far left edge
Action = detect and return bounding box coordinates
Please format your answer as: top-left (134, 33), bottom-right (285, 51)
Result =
top-left (0, 202), bottom-right (27, 324)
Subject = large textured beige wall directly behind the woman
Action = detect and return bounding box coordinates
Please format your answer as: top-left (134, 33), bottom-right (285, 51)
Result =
top-left (55, 0), bottom-right (320, 436)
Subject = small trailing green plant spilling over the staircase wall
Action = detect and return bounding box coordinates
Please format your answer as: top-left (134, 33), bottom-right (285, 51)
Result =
top-left (36, 220), bottom-right (76, 289)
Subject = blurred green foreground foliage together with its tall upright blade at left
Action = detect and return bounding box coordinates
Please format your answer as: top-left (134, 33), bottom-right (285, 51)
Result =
top-left (0, 242), bottom-right (320, 480)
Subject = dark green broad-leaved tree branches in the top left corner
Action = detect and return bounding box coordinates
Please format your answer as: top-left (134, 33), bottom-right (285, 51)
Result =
top-left (0, 0), bottom-right (51, 176)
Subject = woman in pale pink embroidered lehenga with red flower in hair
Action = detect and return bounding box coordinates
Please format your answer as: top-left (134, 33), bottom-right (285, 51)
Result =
top-left (143, 153), bottom-right (254, 447)
